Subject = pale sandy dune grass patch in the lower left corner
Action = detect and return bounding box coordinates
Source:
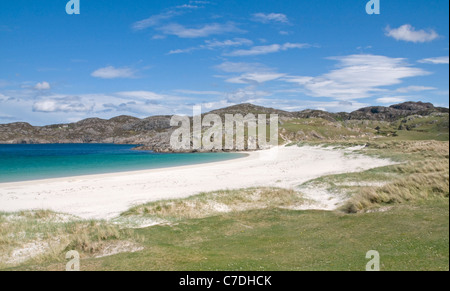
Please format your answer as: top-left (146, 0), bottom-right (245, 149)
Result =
top-left (0, 210), bottom-right (140, 268)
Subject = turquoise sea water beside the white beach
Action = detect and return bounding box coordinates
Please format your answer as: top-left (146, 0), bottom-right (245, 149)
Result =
top-left (0, 144), bottom-right (242, 183)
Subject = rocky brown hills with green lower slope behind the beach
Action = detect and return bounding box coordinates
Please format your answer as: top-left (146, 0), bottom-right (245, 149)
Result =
top-left (0, 102), bottom-right (449, 151)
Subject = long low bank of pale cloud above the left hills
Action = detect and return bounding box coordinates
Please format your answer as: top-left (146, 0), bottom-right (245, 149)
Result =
top-left (0, 90), bottom-right (192, 125)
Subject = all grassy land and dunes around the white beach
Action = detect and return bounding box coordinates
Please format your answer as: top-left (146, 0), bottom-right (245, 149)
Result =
top-left (0, 115), bottom-right (449, 271)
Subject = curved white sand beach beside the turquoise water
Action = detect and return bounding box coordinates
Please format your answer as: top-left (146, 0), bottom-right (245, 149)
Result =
top-left (0, 146), bottom-right (392, 219)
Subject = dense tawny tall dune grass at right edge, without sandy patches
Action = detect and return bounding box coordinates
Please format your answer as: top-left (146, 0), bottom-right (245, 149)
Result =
top-left (343, 141), bottom-right (449, 213)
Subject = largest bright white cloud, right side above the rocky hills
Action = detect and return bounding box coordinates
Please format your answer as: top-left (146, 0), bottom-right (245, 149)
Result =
top-left (286, 55), bottom-right (429, 100)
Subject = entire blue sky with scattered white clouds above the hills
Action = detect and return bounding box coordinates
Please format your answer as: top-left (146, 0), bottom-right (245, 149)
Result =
top-left (0, 0), bottom-right (449, 125)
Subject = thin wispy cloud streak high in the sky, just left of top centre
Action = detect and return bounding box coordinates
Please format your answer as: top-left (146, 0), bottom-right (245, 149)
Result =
top-left (157, 22), bottom-right (243, 38)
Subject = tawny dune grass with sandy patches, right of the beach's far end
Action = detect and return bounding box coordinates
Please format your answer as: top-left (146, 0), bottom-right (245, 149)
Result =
top-left (290, 140), bottom-right (449, 213)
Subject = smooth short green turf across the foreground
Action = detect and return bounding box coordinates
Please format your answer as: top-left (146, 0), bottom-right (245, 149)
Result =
top-left (8, 199), bottom-right (449, 271)
